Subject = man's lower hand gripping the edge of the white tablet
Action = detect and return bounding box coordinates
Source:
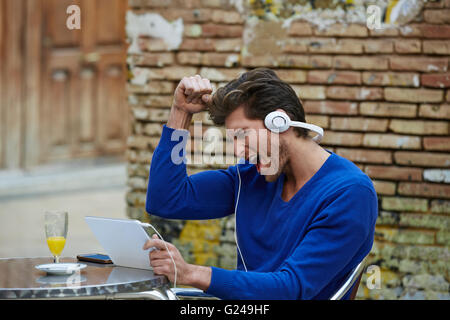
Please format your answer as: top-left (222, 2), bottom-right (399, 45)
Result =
top-left (143, 235), bottom-right (212, 290)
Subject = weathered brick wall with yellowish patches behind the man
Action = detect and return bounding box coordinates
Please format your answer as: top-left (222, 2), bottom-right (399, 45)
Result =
top-left (127, 0), bottom-right (450, 299)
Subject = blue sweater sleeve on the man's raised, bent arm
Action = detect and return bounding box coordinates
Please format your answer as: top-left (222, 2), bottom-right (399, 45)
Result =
top-left (146, 125), bottom-right (236, 220)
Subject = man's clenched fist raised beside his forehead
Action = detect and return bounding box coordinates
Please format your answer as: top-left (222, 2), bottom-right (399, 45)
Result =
top-left (167, 74), bottom-right (212, 130)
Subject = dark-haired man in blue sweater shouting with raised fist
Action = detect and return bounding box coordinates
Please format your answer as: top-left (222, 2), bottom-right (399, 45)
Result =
top-left (144, 68), bottom-right (378, 299)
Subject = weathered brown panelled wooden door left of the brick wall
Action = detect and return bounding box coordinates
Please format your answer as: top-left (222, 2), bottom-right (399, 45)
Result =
top-left (39, 0), bottom-right (129, 162)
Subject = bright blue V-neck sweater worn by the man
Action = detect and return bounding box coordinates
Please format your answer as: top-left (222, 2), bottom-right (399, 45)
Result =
top-left (146, 126), bottom-right (378, 299)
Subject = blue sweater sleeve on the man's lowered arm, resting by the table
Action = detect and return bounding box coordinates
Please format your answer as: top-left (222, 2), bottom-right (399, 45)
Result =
top-left (207, 185), bottom-right (378, 300)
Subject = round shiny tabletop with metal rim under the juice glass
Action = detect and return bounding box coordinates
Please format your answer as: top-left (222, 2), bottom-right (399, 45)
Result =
top-left (0, 257), bottom-right (169, 299)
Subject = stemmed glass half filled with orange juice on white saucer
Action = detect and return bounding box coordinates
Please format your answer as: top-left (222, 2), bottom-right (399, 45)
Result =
top-left (45, 210), bottom-right (69, 263)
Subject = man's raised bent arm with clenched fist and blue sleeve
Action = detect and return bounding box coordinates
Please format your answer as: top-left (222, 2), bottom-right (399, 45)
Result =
top-left (146, 75), bottom-right (236, 220)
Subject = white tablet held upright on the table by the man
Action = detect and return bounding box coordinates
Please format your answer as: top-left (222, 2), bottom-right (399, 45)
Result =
top-left (84, 217), bottom-right (152, 270)
